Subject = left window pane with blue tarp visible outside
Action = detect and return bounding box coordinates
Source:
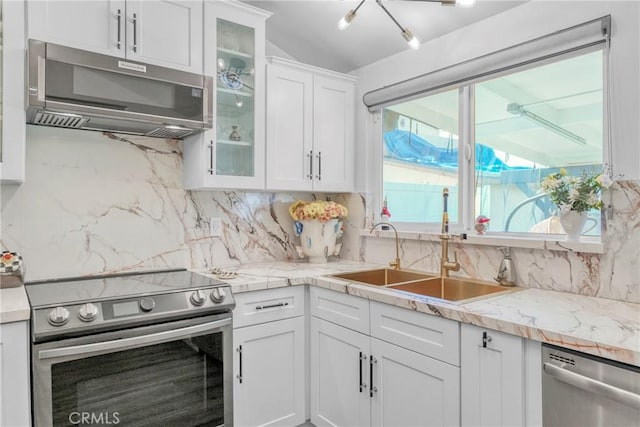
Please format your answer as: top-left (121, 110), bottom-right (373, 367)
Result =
top-left (382, 90), bottom-right (459, 224)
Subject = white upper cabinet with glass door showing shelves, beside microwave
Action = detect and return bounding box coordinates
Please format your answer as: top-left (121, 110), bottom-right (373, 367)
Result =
top-left (184, 1), bottom-right (269, 189)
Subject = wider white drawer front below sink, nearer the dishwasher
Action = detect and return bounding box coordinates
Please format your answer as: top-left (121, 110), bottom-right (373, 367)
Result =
top-left (370, 302), bottom-right (460, 366)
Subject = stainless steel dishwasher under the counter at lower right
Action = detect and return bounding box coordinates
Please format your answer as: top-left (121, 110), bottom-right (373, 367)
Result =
top-left (542, 344), bottom-right (640, 427)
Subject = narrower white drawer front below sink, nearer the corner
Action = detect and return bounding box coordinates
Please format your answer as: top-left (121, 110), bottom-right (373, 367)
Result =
top-left (309, 286), bottom-right (369, 335)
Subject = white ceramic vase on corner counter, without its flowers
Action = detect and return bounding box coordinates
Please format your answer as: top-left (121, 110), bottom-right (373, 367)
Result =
top-left (296, 219), bottom-right (342, 264)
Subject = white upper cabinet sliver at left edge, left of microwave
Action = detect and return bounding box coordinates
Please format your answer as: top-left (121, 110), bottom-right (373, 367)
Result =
top-left (0, 0), bottom-right (26, 183)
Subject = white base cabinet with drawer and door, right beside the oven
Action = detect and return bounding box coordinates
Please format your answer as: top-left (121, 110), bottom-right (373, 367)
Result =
top-left (233, 286), bottom-right (306, 427)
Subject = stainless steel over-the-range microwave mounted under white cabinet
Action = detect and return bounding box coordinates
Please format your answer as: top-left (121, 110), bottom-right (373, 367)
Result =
top-left (27, 40), bottom-right (213, 138)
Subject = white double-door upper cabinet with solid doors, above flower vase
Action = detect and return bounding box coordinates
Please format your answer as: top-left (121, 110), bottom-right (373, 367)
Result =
top-left (267, 58), bottom-right (355, 192)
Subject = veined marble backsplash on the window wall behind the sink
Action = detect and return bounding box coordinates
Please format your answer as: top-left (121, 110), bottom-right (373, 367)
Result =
top-left (362, 180), bottom-right (640, 303)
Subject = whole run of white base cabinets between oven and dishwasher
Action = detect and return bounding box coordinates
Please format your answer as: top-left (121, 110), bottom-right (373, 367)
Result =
top-left (234, 286), bottom-right (542, 427)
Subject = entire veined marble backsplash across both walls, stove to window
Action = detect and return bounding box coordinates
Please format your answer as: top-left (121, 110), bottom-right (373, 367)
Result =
top-left (0, 126), bottom-right (640, 302)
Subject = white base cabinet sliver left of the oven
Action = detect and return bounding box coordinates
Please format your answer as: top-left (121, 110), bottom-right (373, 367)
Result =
top-left (0, 321), bottom-right (31, 427)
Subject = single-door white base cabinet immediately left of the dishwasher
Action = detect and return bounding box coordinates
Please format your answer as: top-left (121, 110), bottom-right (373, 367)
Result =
top-left (460, 324), bottom-right (541, 427)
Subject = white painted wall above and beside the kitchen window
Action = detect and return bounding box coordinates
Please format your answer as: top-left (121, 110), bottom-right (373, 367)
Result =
top-left (352, 0), bottom-right (640, 192)
